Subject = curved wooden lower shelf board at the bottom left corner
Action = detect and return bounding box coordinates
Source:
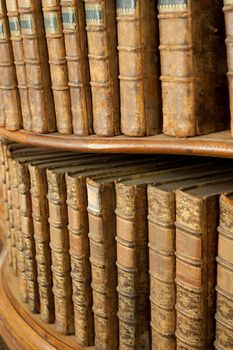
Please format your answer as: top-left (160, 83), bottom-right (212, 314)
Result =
top-left (0, 249), bottom-right (94, 350)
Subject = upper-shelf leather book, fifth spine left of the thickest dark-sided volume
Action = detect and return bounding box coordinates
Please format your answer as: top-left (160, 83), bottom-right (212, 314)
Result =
top-left (42, 0), bottom-right (72, 134)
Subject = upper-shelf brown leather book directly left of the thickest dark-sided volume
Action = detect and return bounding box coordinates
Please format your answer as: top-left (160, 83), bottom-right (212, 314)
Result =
top-left (117, 0), bottom-right (162, 136)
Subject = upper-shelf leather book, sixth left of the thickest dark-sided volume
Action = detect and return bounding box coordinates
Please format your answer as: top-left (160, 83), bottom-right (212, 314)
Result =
top-left (17, 0), bottom-right (56, 133)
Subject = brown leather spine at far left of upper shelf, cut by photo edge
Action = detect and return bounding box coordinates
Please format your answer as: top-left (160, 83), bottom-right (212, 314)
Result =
top-left (0, 0), bottom-right (22, 130)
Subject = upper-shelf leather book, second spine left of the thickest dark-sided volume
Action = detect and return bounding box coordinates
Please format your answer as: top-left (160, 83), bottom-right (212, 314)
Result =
top-left (84, 0), bottom-right (120, 136)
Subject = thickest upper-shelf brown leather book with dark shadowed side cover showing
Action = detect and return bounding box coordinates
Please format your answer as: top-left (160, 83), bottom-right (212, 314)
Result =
top-left (158, 0), bottom-right (229, 137)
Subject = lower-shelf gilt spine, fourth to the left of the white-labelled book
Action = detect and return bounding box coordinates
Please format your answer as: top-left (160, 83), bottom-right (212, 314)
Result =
top-left (17, 162), bottom-right (40, 313)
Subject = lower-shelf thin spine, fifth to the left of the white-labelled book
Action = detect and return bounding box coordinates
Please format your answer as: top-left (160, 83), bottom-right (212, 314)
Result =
top-left (9, 157), bottom-right (28, 303)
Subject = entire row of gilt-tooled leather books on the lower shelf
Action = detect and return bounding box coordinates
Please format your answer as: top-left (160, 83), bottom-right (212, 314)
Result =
top-left (1, 141), bottom-right (233, 350)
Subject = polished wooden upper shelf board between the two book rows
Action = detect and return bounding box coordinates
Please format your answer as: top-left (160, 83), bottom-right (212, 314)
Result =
top-left (0, 128), bottom-right (233, 158)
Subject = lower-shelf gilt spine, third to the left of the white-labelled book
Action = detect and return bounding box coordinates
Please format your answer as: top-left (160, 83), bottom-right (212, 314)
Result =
top-left (29, 165), bottom-right (54, 323)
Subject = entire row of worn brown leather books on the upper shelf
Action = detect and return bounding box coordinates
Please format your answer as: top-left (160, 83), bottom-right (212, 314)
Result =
top-left (0, 0), bottom-right (233, 137)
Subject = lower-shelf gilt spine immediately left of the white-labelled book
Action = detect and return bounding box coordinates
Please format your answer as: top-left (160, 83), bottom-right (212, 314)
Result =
top-left (66, 175), bottom-right (94, 346)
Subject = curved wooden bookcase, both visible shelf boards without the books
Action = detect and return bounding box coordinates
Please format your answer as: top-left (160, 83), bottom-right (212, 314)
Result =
top-left (0, 128), bottom-right (233, 350)
